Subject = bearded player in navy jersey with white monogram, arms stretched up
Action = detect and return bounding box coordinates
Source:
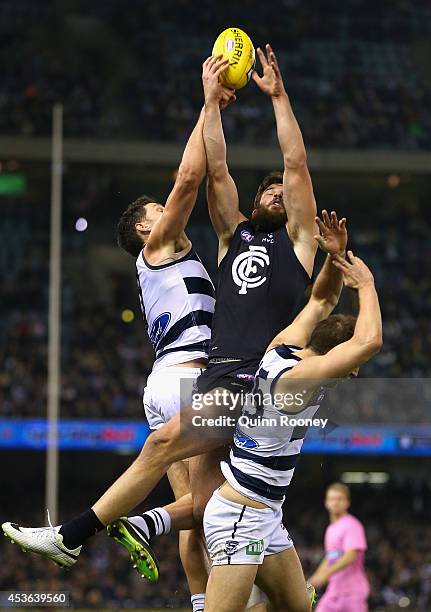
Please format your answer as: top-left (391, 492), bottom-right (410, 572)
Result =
top-left (190, 45), bottom-right (318, 517)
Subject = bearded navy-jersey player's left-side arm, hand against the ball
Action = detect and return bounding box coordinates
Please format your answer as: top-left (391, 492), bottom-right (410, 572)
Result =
top-left (202, 56), bottom-right (245, 261)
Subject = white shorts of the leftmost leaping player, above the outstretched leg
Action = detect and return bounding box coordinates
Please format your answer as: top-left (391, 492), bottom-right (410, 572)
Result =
top-left (143, 366), bottom-right (204, 429)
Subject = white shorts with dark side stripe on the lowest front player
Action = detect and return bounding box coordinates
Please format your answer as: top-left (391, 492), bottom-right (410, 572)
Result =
top-left (204, 490), bottom-right (293, 565)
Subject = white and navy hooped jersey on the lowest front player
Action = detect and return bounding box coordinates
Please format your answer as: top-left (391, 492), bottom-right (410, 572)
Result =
top-left (221, 345), bottom-right (324, 508)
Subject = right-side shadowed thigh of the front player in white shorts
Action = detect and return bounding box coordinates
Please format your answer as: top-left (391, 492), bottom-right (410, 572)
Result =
top-left (256, 546), bottom-right (311, 612)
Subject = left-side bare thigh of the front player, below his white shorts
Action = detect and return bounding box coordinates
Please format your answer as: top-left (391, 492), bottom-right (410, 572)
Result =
top-left (205, 565), bottom-right (258, 612)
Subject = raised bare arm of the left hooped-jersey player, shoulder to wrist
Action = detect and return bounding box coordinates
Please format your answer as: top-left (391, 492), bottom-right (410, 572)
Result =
top-left (145, 109), bottom-right (206, 253)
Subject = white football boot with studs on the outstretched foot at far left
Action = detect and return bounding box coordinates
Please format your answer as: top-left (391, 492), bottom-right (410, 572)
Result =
top-left (2, 518), bottom-right (82, 569)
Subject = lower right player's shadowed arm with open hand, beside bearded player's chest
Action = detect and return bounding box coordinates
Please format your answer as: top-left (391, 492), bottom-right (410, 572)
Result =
top-left (269, 210), bottom-right (347, 348)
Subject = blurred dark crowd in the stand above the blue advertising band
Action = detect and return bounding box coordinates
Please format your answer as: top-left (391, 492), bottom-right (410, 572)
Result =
top-left (0, 191), bottom-right (431, 422)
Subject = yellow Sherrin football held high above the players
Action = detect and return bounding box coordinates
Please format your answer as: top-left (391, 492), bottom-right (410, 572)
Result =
top-left (212, 28), bottom-right (256, 89)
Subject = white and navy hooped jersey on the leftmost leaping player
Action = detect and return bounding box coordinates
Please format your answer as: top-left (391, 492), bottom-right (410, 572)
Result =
top-left (136, 245), bottom-right (215, 371)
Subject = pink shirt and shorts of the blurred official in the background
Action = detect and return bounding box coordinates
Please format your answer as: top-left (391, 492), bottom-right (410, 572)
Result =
top-left (318, 514), bottom-right (369, 612)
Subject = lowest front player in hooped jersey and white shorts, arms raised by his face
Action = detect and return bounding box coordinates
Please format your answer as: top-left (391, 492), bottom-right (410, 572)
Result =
top-left (204, 213), bottom-right (382, 612)
